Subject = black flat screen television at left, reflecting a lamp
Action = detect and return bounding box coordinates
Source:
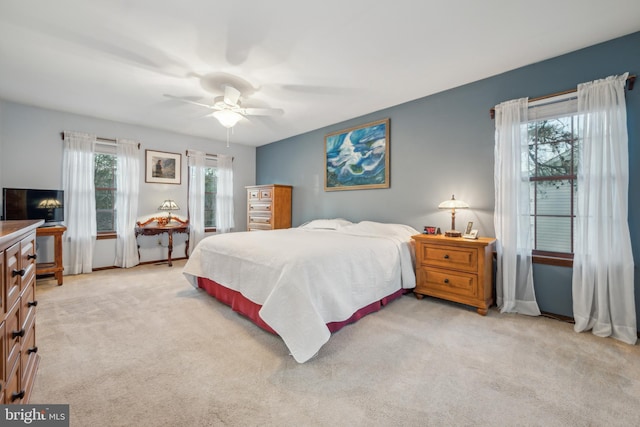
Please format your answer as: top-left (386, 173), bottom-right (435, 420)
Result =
top-left (2, 188), bottom-right (64, 225)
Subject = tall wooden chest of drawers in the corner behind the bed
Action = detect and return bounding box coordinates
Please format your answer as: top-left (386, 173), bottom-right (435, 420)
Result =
top-left (245, 184), bottom-right (293, 231)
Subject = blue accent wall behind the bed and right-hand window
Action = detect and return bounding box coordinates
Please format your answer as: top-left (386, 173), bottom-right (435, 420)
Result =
top-left (256, 32), bottom-right (640, 330)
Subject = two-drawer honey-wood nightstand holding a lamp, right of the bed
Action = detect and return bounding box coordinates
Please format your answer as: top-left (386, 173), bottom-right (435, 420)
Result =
top-left (413, 234), bottom-right (495, 316)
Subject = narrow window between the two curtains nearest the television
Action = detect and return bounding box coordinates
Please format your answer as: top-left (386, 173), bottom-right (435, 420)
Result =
top-left (94, 152), bottom-right (118, 234)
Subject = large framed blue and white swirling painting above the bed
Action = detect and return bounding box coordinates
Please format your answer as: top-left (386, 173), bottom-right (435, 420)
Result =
top-left (324, 118), bottom-right (390, 191)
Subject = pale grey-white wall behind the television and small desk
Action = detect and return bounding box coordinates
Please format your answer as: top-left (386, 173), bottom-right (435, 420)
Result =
top-left (0, 100), bottom-right (256, 268)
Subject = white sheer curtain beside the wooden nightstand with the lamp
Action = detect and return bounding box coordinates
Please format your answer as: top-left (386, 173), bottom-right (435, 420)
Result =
top-left (493, 98), bottom-right (540, 316)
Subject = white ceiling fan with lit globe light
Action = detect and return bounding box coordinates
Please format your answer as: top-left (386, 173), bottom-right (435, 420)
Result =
top-left (164, 85), bottom-right (284, 129)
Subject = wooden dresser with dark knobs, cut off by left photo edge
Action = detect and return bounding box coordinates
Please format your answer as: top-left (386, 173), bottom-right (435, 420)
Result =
top-left (0, 220), bottom-right (43, 403)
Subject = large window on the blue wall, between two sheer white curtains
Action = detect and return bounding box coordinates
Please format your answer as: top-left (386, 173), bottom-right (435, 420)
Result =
top-left (527, 96), bottom-right (580, 258)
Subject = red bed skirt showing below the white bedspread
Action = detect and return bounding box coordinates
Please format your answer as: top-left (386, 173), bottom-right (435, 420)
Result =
top-left (198, 277), bottom-right (408, 335)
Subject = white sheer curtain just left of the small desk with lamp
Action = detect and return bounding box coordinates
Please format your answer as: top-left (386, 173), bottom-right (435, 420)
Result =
top-left (115, 139), bottom-right (140, 268)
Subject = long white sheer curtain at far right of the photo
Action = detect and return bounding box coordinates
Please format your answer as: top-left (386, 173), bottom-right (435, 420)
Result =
top-left (573, 74), bottom-right (637, 344)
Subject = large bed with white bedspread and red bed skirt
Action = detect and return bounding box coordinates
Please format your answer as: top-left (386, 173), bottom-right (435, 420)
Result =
top-left (183, 219), bottom-right (419, 363)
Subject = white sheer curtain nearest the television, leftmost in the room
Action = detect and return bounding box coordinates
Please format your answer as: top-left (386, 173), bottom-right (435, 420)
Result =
top-left (62, 132), bottom-right (97, 274)
